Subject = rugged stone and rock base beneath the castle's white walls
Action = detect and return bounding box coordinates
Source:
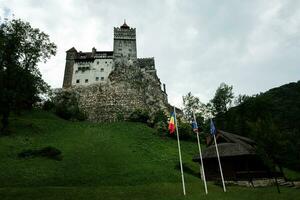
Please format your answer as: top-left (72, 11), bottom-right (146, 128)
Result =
top-left (64, 61), bottom-right (168, 122)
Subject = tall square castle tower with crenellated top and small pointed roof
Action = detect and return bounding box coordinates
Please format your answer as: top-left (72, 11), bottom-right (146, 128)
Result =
top-left (114, 21), bottom-right (137, 60)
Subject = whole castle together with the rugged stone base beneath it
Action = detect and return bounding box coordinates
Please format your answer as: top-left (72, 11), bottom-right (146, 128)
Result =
top-left (63, 21), bottom-right (169, 122)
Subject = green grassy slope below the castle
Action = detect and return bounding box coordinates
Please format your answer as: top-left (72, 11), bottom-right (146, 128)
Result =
top-left (0, 111), bottom-right (300, 200)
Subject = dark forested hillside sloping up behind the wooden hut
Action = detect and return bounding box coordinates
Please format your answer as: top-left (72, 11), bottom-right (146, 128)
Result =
top-left (216, 81), bottom-right (300, 170)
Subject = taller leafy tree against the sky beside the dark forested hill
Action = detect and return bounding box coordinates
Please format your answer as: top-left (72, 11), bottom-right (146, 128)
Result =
top-left (211, 83), bottom-right (234, 115)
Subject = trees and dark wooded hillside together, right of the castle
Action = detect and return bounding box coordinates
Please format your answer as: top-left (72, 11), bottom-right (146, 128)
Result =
top-left (183, 81), bottom-right (300, 171)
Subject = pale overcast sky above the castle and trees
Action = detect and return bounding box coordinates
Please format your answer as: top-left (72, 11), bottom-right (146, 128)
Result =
top-left (0, 0), bottom-right (300, 106)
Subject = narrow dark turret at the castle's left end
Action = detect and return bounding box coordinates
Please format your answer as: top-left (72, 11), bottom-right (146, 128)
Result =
top-left (63, 47), bottom-right (77, 88)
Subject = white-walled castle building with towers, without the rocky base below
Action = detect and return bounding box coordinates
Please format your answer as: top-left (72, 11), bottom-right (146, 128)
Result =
top-left (63, 21), bottom-right (166, 92)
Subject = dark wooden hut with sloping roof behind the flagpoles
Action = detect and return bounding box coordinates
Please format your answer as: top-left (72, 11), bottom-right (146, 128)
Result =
top-left (193, 130), bottom-right (278, 181)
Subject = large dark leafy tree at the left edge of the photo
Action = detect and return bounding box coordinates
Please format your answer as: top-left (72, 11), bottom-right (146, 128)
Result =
top-left (0, 19), bottom-right (56, 133)
